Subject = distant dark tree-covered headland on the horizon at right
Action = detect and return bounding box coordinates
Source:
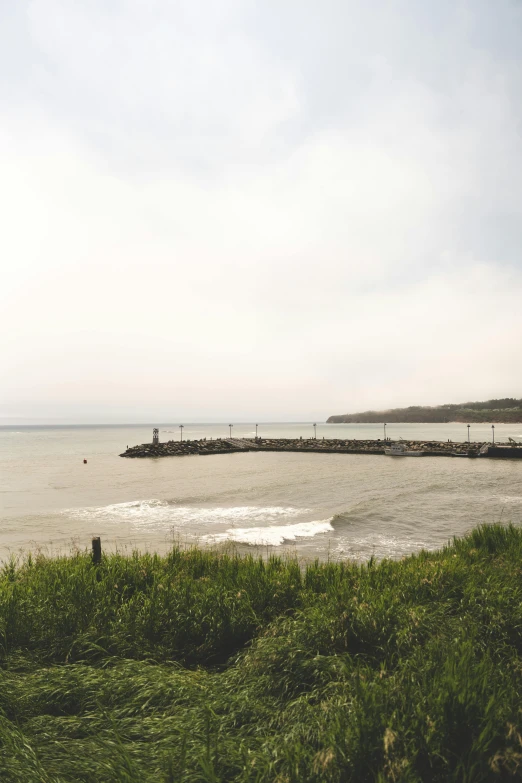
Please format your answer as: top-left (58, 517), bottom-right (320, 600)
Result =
top-left (326, 397), bottom-right (522, 424)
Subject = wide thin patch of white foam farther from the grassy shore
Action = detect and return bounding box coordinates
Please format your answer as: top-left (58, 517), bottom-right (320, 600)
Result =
top-left (63, 498), bottom-right (308, 529)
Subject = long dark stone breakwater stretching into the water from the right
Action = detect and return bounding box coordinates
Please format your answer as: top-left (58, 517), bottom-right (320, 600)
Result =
top-left (120, 438), bottom-right (522, 459)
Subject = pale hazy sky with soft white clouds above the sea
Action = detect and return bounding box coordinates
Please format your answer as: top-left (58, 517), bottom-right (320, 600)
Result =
top-left (0, 0), bottom-right (522, 423)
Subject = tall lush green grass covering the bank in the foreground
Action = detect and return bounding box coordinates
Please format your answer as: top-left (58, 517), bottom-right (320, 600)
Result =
top-left (0, 525), bottom-right (522, 783)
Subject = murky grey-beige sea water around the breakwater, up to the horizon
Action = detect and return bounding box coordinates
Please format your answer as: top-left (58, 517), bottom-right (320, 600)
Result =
top-left (0, 423), bottom-right (522, 559)
